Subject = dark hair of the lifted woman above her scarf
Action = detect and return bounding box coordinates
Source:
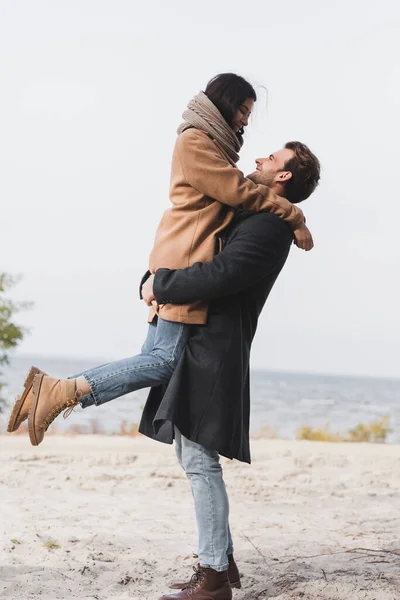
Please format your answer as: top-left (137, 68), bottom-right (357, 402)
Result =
top-left (204, 73), bottom-right (257, 133)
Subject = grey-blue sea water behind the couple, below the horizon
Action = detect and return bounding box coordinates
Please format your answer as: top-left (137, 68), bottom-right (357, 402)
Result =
top-left (0, 357), bottom-right (400, 443)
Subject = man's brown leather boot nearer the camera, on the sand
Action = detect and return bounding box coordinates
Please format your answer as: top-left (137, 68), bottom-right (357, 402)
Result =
top-left (159, 566), bottom-right (232, 600)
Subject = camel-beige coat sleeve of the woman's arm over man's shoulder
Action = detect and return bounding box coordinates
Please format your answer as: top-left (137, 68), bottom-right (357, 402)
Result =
top-left (175, 129), bottom-right (305, 230)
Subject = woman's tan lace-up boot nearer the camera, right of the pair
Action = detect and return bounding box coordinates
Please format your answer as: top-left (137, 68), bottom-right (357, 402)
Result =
top-left (28, 374), bottom-right (83, 446)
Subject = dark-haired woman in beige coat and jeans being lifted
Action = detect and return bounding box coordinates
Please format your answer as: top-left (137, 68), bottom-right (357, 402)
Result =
top-left (8, 73), bottom-right (312, 446)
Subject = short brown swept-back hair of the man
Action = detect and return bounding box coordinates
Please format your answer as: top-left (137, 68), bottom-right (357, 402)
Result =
top-left (285, 142), bottom-right (321, 204)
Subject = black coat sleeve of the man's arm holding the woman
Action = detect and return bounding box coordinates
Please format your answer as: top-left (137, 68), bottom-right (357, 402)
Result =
top-left (153, 215), bottom-right (291, 304)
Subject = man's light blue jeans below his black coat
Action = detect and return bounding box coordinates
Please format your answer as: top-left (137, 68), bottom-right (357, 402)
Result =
top-left (175, 427), bottom-right (233, 571)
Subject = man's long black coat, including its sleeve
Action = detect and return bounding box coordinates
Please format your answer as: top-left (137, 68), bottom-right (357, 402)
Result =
top-left (139, 213), bottom-right (292, 463)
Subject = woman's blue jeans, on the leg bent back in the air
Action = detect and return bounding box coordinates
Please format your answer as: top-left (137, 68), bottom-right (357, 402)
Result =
top-left (75, 318), bottom-right (190, 408)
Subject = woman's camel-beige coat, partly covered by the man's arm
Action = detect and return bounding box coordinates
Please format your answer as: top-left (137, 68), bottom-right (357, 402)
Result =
top-left (149, 128), bottom-right (304, 325)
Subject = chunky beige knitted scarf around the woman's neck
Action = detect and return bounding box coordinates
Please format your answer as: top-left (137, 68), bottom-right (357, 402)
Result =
top-left (178, 92), bottom-right (243, 165)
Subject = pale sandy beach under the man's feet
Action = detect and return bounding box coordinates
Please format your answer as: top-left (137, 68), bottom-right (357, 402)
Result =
top-left (0, 435), bottom-right (400, 600)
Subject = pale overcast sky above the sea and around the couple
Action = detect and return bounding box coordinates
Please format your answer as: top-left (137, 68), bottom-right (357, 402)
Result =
top-left (0, 0), bottom-right (400, 376)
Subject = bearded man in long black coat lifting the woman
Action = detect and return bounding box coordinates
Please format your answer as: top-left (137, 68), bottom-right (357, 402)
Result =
top-left (139, 142), bottom-right (320, 600)
